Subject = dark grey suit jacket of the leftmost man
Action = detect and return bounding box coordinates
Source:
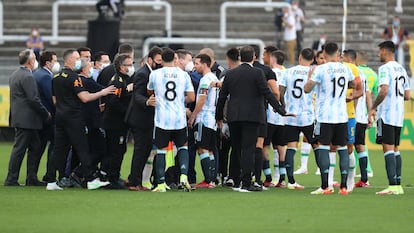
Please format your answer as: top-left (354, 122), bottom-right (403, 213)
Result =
top-left (9, 67), bottom-right (48, 129)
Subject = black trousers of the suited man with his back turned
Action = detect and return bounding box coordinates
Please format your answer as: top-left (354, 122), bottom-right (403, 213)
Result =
top-left (229, 121), bottom-right (259, 187)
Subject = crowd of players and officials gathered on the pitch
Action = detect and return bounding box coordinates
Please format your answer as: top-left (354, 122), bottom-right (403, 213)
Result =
top-left (4, 36), bottom-right (409, 195)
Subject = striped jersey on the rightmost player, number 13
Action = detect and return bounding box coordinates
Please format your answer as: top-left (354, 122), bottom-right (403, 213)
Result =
top-left (377, 61), bottom-right (410, 127)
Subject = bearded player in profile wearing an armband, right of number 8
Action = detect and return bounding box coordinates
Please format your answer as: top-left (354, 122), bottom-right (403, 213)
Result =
top-left (188, 54), bottom-right (218, 188)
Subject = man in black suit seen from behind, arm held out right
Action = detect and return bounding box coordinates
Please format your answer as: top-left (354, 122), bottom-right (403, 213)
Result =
top-left (216, 46), bottom-right (286, 192)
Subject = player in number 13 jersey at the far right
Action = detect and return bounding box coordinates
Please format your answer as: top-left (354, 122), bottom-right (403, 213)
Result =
top-left (369, 41), bottom-right (410, 195)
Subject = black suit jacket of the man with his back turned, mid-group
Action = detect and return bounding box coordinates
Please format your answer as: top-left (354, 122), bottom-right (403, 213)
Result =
top-left (216, 63), bottom-right (286, 124)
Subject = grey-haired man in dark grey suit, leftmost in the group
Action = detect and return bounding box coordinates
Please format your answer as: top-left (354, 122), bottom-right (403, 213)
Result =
top-left (4, 49), bottom-right (51, 186)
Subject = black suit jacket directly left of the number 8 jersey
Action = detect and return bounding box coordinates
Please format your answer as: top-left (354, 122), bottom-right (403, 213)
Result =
top-left (125, 64), bottom-right (155, 129)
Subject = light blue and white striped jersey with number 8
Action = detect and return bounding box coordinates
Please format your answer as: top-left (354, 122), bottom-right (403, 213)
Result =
top-left (147, 67), bottom-right (194, 130)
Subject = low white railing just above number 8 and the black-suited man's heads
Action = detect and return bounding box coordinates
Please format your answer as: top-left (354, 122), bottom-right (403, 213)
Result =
top-left (142, 37), bottom-right (265, 62)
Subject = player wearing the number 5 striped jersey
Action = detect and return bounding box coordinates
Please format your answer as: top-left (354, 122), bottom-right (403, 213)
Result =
top-left (279, 48), bottom-right (317, 189)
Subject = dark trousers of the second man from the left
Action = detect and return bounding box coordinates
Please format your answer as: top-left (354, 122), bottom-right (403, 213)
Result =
top-left (36, 124), bottom-right (55, 181)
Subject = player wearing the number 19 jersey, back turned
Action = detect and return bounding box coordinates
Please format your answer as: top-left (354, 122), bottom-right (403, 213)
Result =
top-left (304, 42), bottom-right (355, 195)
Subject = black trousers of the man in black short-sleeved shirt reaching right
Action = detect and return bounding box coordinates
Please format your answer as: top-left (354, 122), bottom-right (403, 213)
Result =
top-left (46, 116), bottom-right (95, 182)
